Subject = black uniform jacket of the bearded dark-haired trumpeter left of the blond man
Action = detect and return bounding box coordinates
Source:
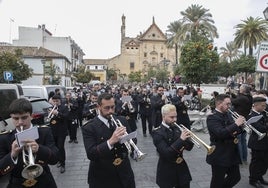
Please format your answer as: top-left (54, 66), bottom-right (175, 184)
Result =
top-left (82, 117), bottom-right (135, 188)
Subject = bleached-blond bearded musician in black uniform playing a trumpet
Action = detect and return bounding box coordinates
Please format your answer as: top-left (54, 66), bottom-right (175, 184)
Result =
top-left (152, 104), bottom-right (194, 188)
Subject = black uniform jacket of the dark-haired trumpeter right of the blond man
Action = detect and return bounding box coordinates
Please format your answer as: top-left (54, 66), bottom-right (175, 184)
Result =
top-left (206, 110), bottom-right (242, 167)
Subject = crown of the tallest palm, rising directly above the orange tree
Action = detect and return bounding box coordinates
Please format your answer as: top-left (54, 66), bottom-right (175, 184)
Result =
top-left (180, 5), bottom-right (219, 40)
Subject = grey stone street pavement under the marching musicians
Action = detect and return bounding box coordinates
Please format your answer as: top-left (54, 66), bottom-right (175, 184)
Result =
top-left (0, 119), bottom-right (268, 188)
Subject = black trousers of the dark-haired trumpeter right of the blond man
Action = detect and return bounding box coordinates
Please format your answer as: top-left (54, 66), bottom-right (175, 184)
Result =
top-left (210, 165), bottom-right (241, 188)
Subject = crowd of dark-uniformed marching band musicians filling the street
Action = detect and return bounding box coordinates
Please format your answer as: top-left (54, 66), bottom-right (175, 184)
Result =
top-left (0, 84), bottom-right (268, 188)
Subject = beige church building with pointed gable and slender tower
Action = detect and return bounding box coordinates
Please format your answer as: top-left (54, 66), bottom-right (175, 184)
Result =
top-left (84, 15), bottom-right (175, 80)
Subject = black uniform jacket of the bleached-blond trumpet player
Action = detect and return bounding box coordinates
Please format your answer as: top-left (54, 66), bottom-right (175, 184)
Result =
top-left (152, 124), bottom-right (193, 187)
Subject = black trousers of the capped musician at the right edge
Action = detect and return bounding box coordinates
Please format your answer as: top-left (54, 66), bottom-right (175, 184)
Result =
top-left (249, 149), bottom-right (268, 182)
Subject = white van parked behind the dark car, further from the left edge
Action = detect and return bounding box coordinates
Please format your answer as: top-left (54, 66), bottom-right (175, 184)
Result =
top-left (21, 85), bottom-right (66, 100)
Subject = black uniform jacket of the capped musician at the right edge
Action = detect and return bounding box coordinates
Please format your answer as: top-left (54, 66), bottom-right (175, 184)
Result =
top-left (248, 111), bottom-right (268, 151)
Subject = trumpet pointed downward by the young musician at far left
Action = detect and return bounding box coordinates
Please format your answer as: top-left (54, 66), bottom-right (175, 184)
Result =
top-left (21, 126), bottom-right (43, 180)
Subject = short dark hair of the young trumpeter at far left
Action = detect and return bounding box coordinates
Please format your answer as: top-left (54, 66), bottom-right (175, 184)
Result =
top-left (8, 98), bottom-right (33, 114)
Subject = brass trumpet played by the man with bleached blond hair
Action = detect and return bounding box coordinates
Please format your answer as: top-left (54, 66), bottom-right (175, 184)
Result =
top-left (173, 122), bottom-right (216, 155)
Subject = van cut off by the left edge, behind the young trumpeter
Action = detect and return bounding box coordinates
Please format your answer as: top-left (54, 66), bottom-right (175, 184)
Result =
top-left (0, 84), bottom-right (23, 132)
